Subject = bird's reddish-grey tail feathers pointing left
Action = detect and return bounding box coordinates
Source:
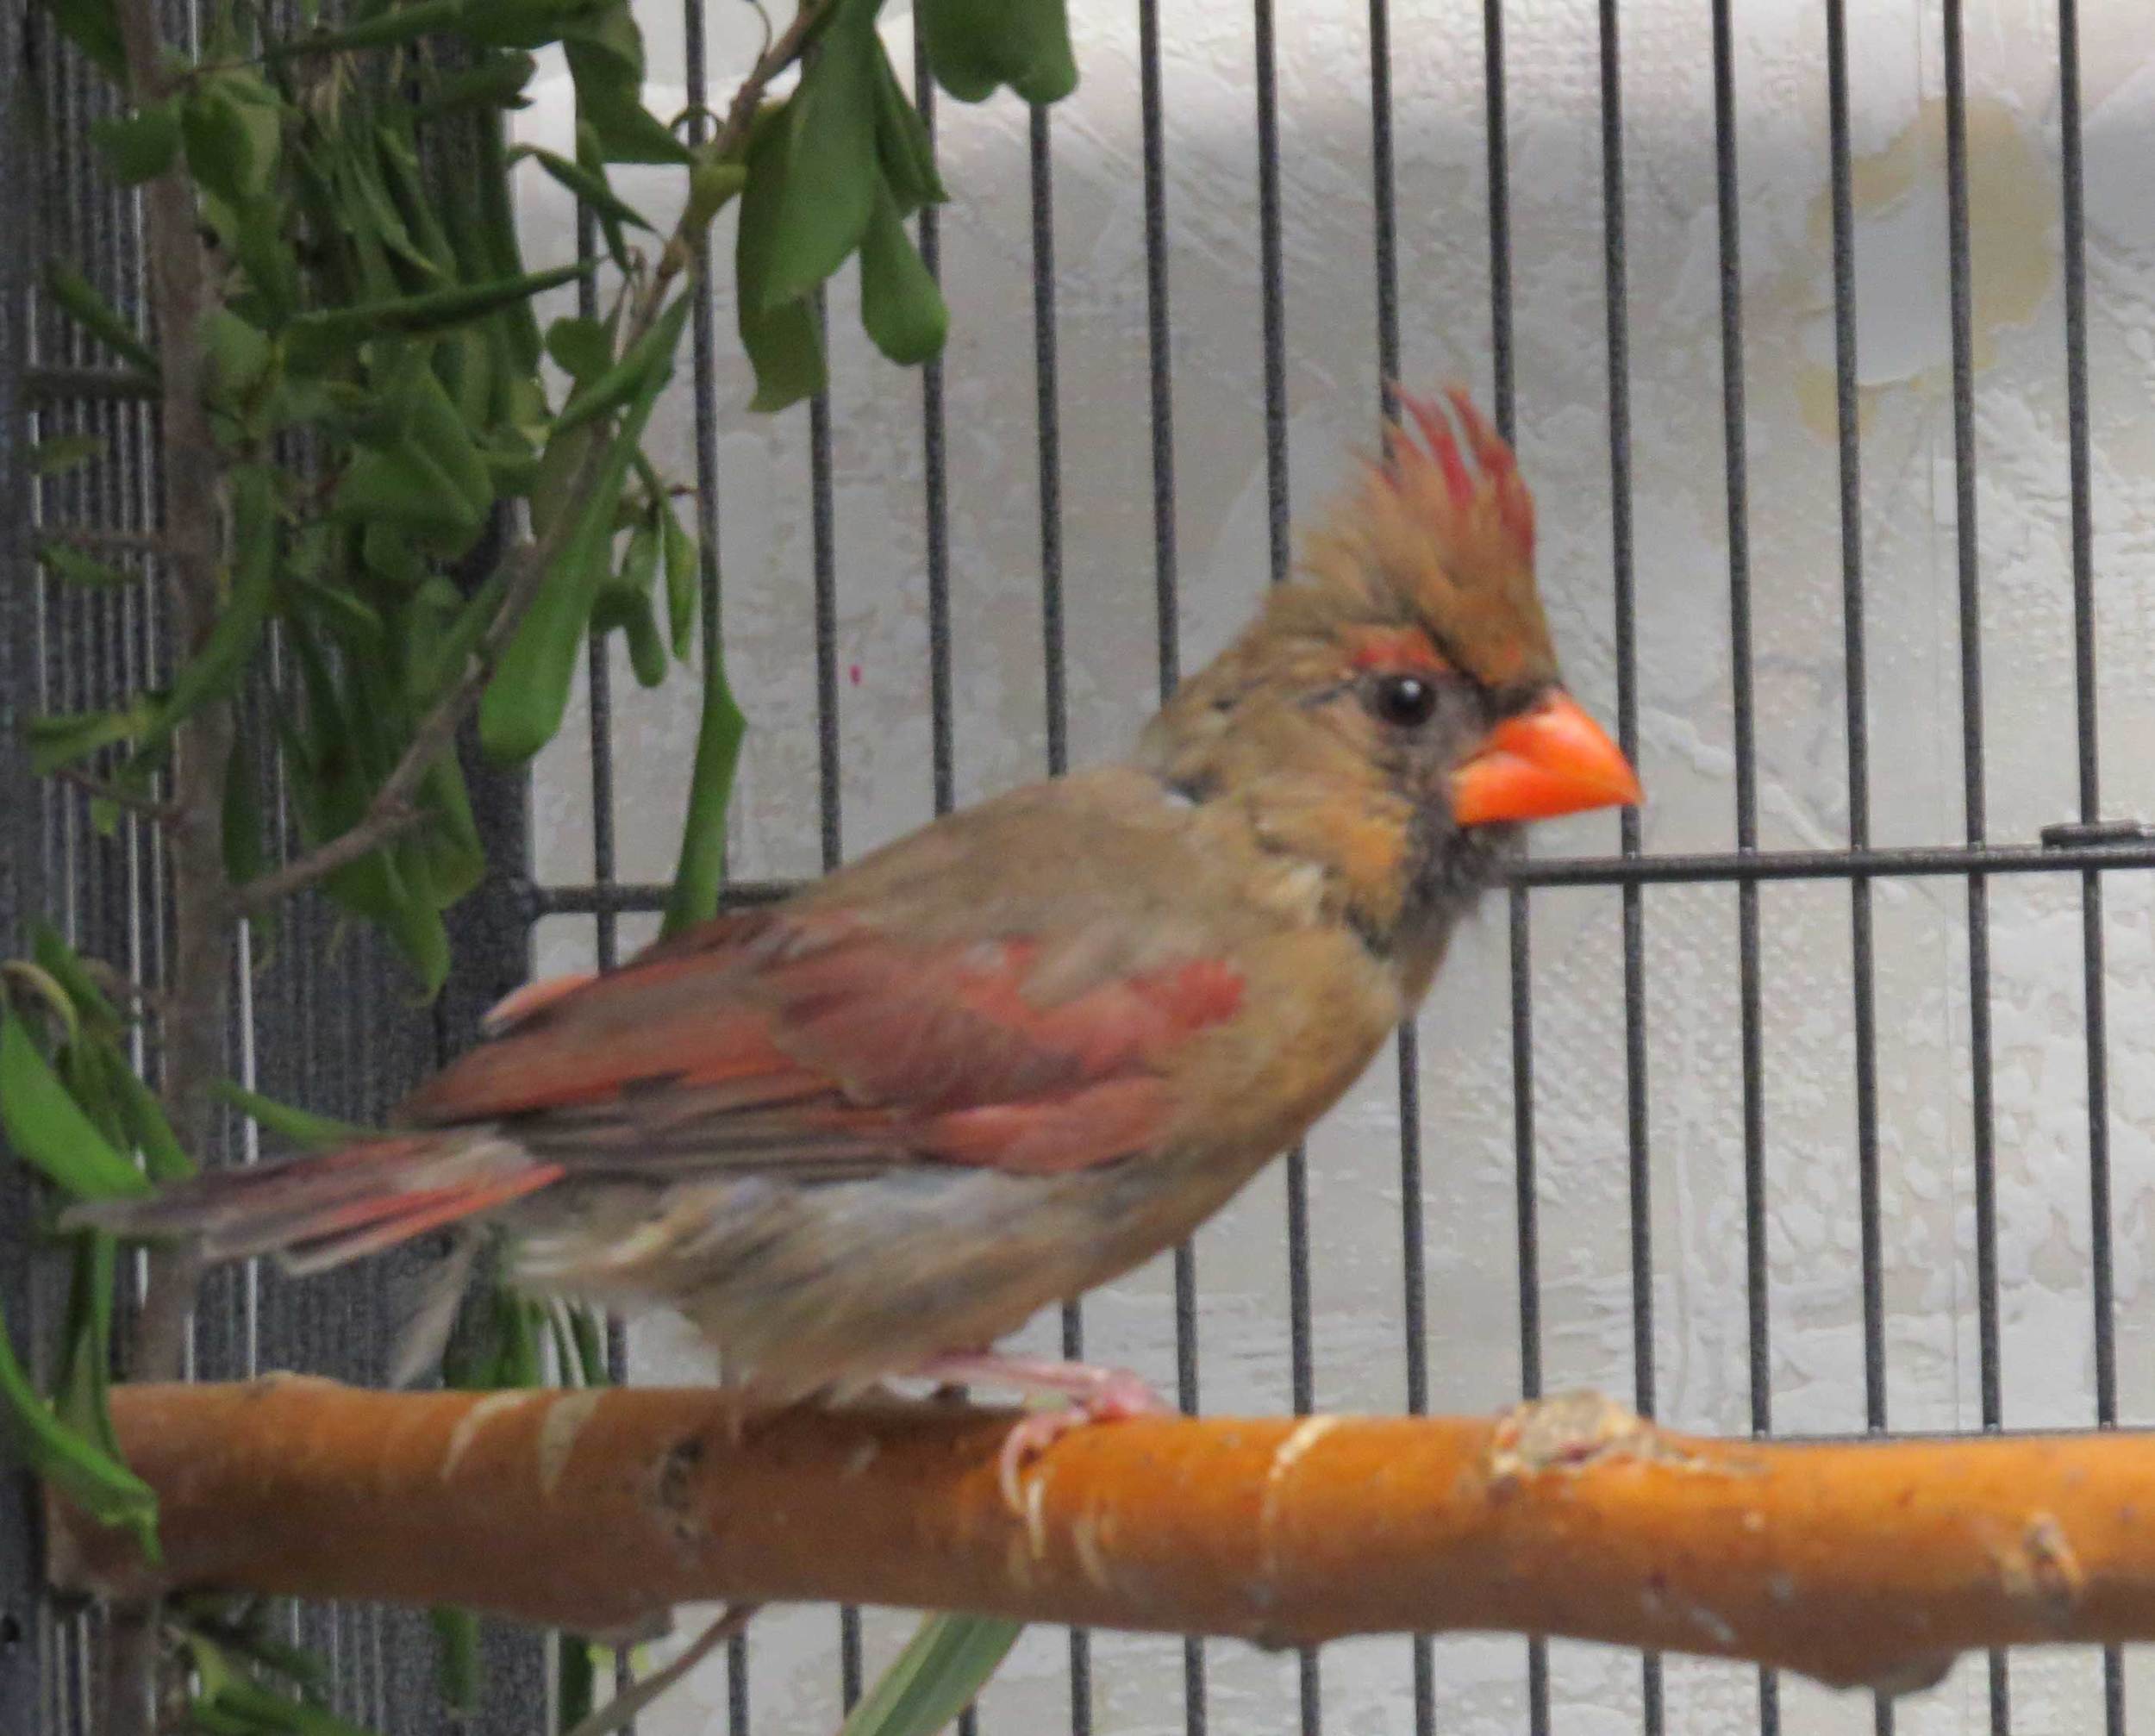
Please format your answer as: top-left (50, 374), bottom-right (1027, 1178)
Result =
top-left (60, 1127), bottom-right (563, 1273)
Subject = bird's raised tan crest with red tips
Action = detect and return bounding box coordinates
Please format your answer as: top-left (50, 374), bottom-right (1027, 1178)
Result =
top-left (1304, 388), bottom-right (1556, 687)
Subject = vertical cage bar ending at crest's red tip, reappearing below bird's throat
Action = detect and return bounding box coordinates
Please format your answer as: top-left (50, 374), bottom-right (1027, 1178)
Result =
top-left (1483, 0), bottom-right (1550, 1736)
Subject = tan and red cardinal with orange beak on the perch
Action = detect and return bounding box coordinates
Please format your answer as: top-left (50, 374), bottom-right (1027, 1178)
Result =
top-left (78, 392), bottom-right (1638, 1480)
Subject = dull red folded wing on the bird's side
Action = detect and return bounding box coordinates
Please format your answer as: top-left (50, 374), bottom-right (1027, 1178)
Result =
top-left (405, 911), bottom-right (1241, 1174)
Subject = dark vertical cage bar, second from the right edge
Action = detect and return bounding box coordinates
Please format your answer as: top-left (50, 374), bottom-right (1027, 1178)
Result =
top-left (1944, 0), bottom-right (2013, 1736)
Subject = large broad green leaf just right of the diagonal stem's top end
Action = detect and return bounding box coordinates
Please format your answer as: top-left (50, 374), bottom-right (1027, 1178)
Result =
top-left (763, 0), bottom-right (882, 312)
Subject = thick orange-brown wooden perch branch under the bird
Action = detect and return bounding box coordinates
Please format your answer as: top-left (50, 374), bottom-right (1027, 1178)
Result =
top-left (52, 1377), bottom-right (2155, 1691)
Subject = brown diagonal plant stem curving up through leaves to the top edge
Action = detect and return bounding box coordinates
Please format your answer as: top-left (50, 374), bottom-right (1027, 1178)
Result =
top-left (229, 0), bottom-right (832, 915)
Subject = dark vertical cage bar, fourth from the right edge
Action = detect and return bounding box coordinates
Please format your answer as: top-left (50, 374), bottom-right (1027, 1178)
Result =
top-left (1714, 0), bottom-right (1780, 1736)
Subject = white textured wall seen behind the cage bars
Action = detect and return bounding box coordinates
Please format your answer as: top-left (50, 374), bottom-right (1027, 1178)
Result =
top-left (513, 0), bottom-right (2155, 1736)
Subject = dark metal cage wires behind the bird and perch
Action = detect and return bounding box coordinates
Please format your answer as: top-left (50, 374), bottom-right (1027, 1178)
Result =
top-left (0, 0), bottom-right (2155, 1736)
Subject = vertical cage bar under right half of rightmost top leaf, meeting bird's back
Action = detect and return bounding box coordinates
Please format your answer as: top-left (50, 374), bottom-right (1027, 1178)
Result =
top-left (1026, 103), bottom-right (1093, 1736)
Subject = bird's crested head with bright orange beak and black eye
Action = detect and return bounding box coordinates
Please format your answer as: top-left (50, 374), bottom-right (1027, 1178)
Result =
top-left (1142, 390), bottom-right (1640, 965)
